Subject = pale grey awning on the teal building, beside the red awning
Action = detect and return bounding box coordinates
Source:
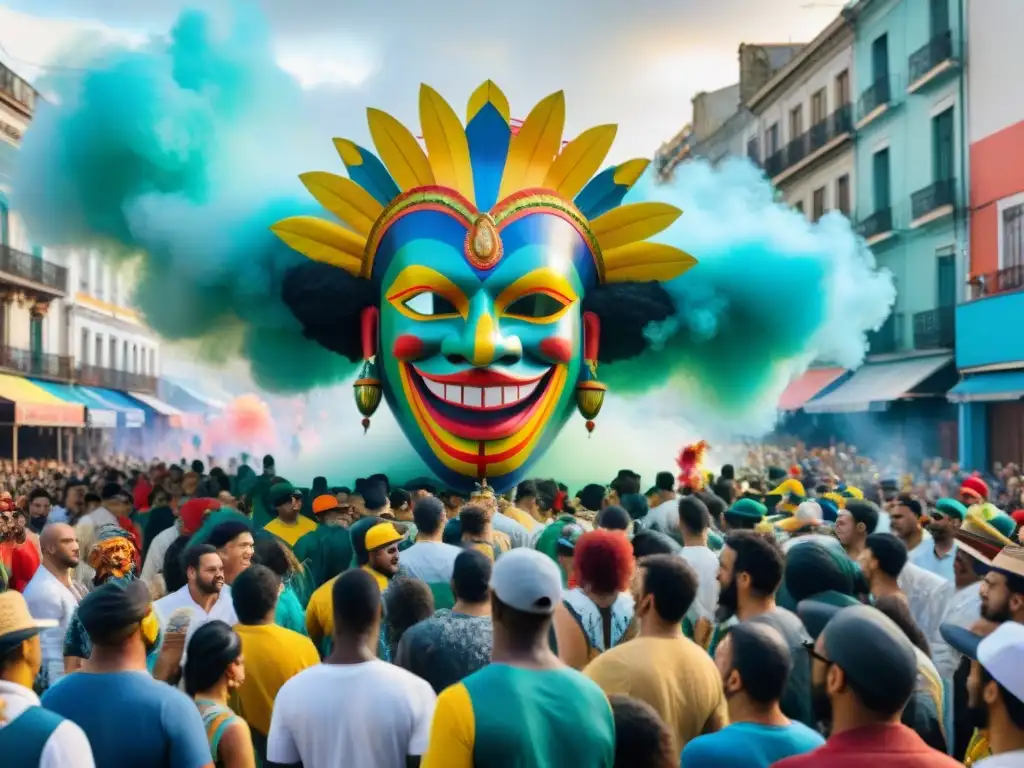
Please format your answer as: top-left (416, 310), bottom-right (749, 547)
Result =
top-left (804, 354), bottom-right (952, 414)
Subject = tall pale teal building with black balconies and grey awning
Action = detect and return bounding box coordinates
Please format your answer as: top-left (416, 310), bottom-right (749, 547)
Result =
top-left (805, 0), bottom-right (968, 458)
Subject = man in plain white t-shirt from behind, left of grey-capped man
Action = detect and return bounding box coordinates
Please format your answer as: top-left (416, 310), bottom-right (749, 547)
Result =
top-left (264, 569), bottom-right (436, 768)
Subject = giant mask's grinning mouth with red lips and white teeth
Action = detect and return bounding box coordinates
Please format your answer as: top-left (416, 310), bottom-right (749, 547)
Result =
top-left (407, 364), bottom-right (551, 440)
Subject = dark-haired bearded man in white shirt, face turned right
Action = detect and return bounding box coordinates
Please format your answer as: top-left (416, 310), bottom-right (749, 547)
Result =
top-left (153, 544), bottom-right (239, 644)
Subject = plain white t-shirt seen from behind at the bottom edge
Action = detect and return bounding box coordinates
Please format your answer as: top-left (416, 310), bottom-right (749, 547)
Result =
top-left (266, 659), bottom-right (437, 768)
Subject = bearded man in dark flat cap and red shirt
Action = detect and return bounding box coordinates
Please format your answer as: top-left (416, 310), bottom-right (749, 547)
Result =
top-left (773, 603), bottom-right (959, 768)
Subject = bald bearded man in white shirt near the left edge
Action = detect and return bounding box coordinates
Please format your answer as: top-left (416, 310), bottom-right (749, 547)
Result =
top-left (24, 522), bottom-right (86, 690)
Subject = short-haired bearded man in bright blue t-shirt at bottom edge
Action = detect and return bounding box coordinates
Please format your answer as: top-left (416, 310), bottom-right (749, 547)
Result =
top-left (682, 622), bottom-right (825, 768)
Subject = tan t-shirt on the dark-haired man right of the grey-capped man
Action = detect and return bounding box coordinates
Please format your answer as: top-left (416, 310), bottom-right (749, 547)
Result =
top-left (583, 637), bottom-right (729, 755)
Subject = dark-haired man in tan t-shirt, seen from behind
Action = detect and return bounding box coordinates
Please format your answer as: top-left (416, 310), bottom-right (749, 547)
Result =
top-left (584, 555), bottom-right (729, 755)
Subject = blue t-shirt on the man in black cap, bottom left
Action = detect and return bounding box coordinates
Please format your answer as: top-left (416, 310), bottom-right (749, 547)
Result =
top-left (42, 672), bottom-right (213, 768)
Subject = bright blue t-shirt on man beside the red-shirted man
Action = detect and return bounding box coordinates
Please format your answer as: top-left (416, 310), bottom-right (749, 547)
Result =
top-left (681, 720), bottom-right (825, 768)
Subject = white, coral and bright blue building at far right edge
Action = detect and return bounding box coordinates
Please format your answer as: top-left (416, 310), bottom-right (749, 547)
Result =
top-left (950, 0), bottom-right (1024, 468)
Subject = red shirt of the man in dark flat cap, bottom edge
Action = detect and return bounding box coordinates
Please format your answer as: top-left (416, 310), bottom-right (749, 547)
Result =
top-left (772, 725), bottom-right (964, 768)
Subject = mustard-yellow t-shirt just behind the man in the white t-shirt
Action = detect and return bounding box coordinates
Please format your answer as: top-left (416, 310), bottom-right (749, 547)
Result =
top-left (231, 624), bottom-right (319, 736)
